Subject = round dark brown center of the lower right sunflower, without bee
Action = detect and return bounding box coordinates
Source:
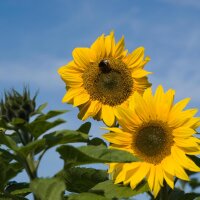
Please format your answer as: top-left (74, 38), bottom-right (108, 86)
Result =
top-left (133, 121), bottom-right (173, 164)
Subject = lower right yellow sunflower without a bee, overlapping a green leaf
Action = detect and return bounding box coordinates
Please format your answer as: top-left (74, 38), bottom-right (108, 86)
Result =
top-left (104, 86), bottom-right (200, 197)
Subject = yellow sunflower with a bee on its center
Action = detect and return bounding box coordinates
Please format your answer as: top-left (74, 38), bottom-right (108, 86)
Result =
top-left (58, 32), bottom-right (151, 126)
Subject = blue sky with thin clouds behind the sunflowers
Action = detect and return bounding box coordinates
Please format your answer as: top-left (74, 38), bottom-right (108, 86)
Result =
top-left (0, 0), bottom-right (200, 198)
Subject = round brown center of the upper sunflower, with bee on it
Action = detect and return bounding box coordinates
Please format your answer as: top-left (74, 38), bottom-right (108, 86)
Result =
top-left (82, 58), bottom-right (133, 106)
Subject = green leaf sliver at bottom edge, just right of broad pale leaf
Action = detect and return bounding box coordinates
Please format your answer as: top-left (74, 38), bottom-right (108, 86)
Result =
top-left (67, 193), bottom-right (111, 200)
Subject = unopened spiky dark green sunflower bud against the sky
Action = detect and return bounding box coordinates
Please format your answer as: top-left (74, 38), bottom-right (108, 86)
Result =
top-left (0, 87), bottom-right (37, 122)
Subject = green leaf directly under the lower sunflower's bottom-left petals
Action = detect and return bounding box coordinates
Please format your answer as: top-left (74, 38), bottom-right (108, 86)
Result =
top-left (90, 180), bottom-right (149, 199)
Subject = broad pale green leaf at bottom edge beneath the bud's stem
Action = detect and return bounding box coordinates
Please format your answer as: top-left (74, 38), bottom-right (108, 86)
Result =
top-left (30, 178), bottom-right (65, 200)
